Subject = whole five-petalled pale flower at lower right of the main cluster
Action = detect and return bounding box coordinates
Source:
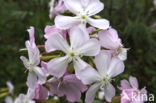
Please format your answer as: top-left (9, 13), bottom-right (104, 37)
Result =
top-left (79, 51), bottom-right (124, 103)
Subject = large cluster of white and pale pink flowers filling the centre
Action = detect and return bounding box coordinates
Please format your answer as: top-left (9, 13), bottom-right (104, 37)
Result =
top-left (5, 0), bottom-right (147, 103)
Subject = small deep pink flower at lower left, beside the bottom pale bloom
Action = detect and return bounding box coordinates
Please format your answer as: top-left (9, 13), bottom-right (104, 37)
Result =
top-left (34, 83), bottom-right (49, 100)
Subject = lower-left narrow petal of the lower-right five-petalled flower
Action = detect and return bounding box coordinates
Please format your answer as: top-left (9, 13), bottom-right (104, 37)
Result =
top-left (85, 83), bottom-right (100, 103)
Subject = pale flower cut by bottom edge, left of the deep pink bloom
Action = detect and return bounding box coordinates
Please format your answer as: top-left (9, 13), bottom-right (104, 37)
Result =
top-left (14, 88), bottom-right (35, 103)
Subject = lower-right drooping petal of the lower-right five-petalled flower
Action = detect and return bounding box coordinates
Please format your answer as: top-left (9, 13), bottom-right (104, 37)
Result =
top-left (104, 82), bottom-right (115, 102)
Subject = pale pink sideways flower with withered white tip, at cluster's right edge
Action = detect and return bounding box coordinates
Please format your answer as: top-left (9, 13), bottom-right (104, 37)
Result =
top-left (98, 28), bottom-right (128, 61)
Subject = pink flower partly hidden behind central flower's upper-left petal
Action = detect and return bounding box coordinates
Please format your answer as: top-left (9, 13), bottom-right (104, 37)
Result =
top-left (44, 25), bottom-right (67, 52)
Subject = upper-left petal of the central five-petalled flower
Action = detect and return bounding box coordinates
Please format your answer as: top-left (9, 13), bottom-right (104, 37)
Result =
top-left (47, 33), bottom-right (69, 53)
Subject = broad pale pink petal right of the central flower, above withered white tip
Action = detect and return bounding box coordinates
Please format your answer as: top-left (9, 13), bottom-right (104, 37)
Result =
top-left (98, 28), bottom-right (122, 49)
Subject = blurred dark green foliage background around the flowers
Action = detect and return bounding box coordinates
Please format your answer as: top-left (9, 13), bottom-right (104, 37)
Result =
top-left (0, 0), bottom-right (156, 103)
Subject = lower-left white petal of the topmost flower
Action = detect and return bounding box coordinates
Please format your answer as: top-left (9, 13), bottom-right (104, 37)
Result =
top-left (55, 15), bottom-right (80, 30)
